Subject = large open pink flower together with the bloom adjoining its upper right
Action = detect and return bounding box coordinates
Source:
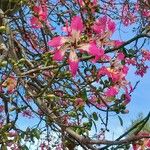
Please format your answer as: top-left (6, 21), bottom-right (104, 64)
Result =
top-left (48, 16), bottom-right (116, 76)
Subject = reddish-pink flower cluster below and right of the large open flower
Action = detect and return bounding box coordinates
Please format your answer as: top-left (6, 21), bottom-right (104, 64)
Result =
top-left (98, 53), bottom-right (132, 104)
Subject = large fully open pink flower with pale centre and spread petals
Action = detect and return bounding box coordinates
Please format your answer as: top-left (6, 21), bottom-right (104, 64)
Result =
top-left (48, 16), bottom-right (104, 76)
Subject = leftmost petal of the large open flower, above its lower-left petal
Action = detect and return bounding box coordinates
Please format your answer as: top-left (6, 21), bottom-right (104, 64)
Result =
top-left (48, 36), bottom-right (64, 47)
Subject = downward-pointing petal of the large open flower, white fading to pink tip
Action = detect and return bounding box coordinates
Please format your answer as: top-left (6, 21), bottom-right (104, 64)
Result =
top-left (69, 51), bottom-right (79, 76)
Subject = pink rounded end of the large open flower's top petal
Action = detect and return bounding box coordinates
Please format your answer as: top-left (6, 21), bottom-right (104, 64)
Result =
top-left (71, 16), bottom-right (83, 32)
